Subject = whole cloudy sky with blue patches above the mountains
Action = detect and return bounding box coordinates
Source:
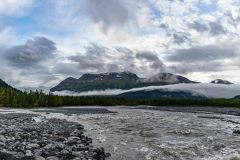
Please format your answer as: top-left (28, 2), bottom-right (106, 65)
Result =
top-left (0, 0), bottom-right (240, 88)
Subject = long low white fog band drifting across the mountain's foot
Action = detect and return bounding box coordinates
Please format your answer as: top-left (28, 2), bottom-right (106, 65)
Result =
top-left (54, 83), bottom-right (240, 98)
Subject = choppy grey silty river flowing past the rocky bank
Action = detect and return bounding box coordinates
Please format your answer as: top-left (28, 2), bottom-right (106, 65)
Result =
top-left (2, 106), bottom-right (240, 160)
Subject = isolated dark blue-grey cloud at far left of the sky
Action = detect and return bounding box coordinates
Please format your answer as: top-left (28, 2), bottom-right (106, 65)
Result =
top-left (3, 37), bottom-right (57, 67)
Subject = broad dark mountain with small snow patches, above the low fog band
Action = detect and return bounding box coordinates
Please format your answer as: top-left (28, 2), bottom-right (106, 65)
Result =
top-left (51, 72), bottom-right (196, 92)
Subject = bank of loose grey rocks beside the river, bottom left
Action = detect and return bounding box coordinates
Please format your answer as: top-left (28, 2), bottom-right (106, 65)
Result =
top-left (0, 113), bottom-right (111, 160)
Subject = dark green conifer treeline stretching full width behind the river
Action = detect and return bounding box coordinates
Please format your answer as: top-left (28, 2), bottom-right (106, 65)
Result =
top-left (0, 89), bottom-right (240, 108)
